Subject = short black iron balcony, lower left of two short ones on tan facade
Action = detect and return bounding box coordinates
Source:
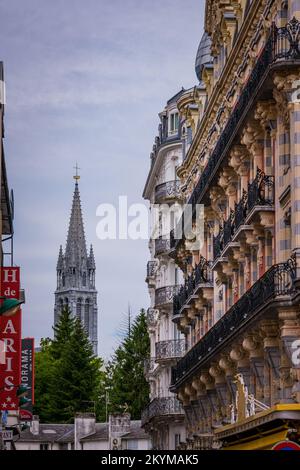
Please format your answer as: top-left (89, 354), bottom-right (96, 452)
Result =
top-left (173, 256), bottom-right (213, 316)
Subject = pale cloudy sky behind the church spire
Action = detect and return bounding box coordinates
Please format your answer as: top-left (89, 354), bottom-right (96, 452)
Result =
top-left (0, 0), bottom-right (204, 357)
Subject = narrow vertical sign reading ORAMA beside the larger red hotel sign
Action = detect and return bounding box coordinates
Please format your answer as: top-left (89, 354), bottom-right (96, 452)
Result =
top-left (20, 338), bottom-right (34, 421)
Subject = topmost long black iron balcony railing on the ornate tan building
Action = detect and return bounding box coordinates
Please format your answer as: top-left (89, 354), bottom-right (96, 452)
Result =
top-left (171, 18), bottom-right (300, 249)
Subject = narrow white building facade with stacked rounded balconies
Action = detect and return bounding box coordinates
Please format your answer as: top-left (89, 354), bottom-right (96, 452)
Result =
top-left (142, 90), bottom-right (185, 450)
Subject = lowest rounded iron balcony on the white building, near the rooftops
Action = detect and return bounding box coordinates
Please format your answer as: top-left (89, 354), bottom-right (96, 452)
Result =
top-left (142, 397), bottom-right (184, 426)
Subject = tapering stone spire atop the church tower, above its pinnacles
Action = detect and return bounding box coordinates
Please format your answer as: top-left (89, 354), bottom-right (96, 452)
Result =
top-left (65, 180), bottom-right (87, 266)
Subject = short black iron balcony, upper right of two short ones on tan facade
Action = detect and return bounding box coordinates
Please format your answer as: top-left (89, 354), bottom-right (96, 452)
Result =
top-left (213, 170), bottom-right (275, 260)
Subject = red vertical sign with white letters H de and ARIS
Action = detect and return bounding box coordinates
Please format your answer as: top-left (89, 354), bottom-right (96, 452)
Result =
top-left (0, 267), bottom-right (21, 411)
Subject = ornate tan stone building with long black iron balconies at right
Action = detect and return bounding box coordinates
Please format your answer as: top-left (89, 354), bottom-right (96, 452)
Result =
top-left (166, 0), bottom-right (300, 449)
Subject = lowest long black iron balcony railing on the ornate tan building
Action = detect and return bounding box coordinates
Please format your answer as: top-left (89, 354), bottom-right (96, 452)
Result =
top-left (172, 258), bottom-right (296, 390)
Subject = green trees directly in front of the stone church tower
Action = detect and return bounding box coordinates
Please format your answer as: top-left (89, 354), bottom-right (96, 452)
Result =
top-left (34, 308), bottom-right (105, 423)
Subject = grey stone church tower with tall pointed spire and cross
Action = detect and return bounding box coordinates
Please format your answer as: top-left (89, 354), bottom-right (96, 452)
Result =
top-left (54, 176), bottom-right (98, 355)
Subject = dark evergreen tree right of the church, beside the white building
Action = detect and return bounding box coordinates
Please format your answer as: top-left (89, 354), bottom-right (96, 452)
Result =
top-left (107, 310), bottom-right (150, 419)
